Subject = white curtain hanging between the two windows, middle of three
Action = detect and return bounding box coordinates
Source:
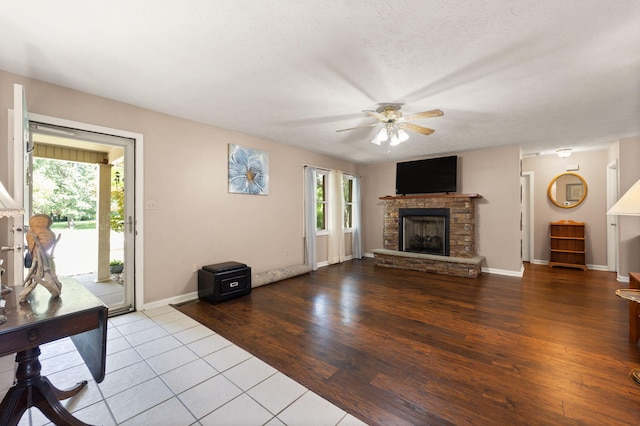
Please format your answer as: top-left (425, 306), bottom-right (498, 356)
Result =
top-left (327, 170), bottom-right (345, 264)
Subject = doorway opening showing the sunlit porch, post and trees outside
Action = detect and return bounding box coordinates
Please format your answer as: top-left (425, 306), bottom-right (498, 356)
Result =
top-left (29, 121), bottom-right (134, 315)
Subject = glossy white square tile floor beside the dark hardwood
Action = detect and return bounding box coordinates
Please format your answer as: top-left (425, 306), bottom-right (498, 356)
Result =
top-left (0, 306), bottom-right (364, 426)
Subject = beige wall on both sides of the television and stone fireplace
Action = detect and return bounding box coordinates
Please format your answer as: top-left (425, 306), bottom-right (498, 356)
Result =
top-left (359, 146), bottom-right (522, 274)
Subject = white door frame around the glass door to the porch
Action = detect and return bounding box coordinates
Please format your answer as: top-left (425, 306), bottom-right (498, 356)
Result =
top-left (29, 113), bottom-right (144, 309)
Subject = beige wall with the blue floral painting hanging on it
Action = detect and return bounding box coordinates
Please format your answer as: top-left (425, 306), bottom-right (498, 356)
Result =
top-left (0, 71), bottom-right (356, 303)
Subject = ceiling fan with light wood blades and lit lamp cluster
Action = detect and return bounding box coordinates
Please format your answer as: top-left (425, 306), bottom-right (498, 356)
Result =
top-left (336, 104), bottom-right (444, 146)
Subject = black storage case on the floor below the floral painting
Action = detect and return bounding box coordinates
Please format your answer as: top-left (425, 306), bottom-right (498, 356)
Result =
top-left (198, 262), bottom-right (251, 303)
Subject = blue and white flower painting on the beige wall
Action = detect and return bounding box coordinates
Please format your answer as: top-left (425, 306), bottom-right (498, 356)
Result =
top-left (229, 144), bottom-right (269, 195)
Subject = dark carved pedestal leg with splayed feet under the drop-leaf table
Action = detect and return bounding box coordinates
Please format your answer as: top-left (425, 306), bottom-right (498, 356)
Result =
top-left (0, 347), bottom-right (92, 426)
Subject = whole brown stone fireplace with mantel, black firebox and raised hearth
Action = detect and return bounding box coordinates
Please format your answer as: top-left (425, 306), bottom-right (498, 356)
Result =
top-left (373, 194), bottom-right (484, 278)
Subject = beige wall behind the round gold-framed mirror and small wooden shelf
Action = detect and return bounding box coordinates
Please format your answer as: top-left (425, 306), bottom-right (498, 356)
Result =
top-left (522, 149), bottom-right (610, 269)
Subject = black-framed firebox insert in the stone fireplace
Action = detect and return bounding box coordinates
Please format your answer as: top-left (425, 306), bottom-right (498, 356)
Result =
top-left (398, 208), bottom-right (449, 256)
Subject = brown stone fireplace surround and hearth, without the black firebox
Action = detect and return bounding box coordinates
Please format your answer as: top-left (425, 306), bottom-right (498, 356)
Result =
top-left (373, 194), bottom-right (484, 278)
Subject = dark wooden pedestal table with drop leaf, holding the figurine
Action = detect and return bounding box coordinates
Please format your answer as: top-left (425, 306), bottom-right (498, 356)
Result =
top-left (0, 282), bottom-right (108, 426)
